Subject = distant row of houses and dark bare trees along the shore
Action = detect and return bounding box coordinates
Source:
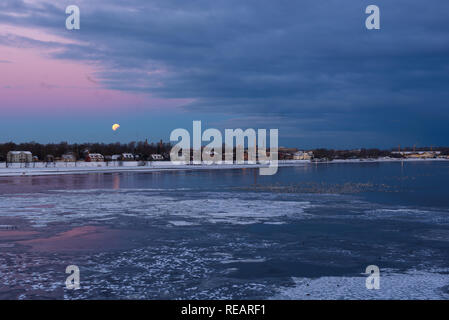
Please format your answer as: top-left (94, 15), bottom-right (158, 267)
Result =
top-left (0, 140), bottom-right (449, 166)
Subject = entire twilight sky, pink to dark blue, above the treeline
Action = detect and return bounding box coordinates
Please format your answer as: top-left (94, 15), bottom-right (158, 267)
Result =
top-left (0, 0), bottom-right (449, 148)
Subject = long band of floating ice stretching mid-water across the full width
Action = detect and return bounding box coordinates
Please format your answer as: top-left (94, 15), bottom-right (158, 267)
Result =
top-left (0, 188), bottom-right (449, 227)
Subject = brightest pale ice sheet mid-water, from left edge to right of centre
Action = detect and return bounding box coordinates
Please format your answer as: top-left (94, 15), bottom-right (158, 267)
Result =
top-left (0, 189), bottom-right (310, 227)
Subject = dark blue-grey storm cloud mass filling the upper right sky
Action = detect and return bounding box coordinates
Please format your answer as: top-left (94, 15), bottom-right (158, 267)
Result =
top-left (0, 0), bottom-right (449, 143)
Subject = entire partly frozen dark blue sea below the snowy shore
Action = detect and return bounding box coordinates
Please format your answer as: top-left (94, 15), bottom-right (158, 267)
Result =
top-left (0, 161), bottom-right (449, 299)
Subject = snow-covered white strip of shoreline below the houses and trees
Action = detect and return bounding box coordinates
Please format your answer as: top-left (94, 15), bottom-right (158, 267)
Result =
top-left (0, 158), bottom-right (449, 177)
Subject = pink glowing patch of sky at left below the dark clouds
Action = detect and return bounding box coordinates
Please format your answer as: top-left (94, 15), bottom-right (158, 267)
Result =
top-left (0, 46), bottom-right (190, 114)
